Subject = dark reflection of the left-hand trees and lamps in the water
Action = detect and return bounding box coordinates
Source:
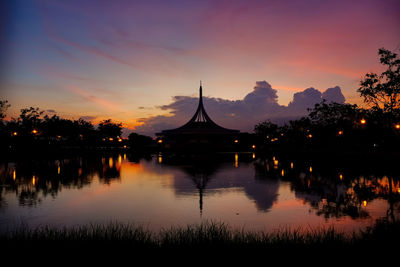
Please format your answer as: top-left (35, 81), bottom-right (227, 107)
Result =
top-left (0, 156), bottom-right (121, 208)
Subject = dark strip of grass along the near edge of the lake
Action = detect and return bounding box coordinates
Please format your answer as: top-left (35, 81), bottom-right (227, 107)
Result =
top-left (0, 221), bottom-right (400, 253)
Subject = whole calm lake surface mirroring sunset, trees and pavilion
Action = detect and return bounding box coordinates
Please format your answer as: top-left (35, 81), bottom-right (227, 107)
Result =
top-left (0, 153), bottom-right (400, 232)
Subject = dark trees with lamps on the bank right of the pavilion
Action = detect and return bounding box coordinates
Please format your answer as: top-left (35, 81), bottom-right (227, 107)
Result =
top-left (254, 48), bottom-right (400, 152)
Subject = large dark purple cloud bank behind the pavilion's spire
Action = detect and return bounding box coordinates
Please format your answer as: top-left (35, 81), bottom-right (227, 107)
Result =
top-left (136, 81), bottom-right (345, 135)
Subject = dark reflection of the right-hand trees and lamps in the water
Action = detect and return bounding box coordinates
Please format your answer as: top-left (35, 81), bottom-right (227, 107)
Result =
top-left (255, 157), bottom-right (400, 220)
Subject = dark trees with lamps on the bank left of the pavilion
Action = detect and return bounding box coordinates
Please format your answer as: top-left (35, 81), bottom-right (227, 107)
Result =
top-left (0, 104), bottom-right (154, 155)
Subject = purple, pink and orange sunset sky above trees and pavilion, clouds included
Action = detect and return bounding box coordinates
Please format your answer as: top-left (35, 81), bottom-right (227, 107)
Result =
top-left (0, 0), bottom-right (400, 134)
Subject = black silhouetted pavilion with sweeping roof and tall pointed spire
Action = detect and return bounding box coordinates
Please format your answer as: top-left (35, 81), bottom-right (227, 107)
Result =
top-left (156, 84), bottom-right (240, 150)
